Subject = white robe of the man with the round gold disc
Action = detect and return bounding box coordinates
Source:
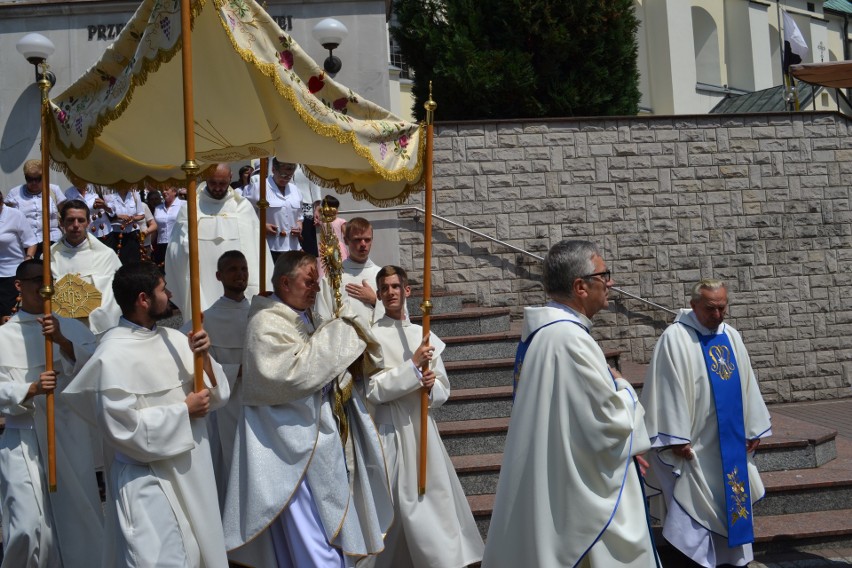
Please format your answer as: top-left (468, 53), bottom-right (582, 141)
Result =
top-left (50, 233), bottom-right (121, 335)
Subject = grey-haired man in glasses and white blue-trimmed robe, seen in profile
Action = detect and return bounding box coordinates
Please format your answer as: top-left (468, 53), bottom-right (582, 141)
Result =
top-left (482, 241), bottom-right (656, 568)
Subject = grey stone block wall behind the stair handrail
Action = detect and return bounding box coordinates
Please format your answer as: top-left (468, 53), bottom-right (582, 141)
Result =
top-left (400, 112), bottom-right (852, 402)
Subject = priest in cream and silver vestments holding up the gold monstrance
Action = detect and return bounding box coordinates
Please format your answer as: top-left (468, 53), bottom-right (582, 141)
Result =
top-left (223, 251), bottom-right (393, 568)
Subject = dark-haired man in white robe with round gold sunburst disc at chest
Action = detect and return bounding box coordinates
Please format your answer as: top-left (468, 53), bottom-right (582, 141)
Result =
top-left (50, 199), bottom-right (121, 335)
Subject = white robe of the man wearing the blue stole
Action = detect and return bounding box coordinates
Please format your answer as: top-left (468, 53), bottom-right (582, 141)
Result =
top-left (641, 310), bottom-right (771, 566)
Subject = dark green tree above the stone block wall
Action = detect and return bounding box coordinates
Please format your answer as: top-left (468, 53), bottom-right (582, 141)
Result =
top-left (391, 0), bottom-right (640, 120)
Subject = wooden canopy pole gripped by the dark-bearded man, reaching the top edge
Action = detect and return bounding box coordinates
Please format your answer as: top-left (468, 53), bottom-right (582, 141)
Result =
top-left (180, 0), bottom-right (204, 392)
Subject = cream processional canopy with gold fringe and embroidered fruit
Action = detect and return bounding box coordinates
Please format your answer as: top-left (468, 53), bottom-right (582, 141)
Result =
top-left (48, 0), bottom-right (426, 205)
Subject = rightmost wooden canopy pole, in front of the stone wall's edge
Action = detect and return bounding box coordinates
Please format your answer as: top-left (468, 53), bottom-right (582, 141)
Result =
top-left (417, 81), bottom-right (438, 495)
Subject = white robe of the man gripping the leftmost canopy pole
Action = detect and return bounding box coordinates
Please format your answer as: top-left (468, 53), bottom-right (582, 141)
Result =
top-left (0, 312), bottom-right (103, 568)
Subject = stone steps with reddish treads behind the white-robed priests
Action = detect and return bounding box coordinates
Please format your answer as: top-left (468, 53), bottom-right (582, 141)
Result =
top-left (409, 292), bottom-right (852, 558)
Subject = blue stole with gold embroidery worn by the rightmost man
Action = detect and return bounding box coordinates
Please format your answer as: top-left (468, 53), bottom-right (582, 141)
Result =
top-left (696, 331), bottom-right (754, 548)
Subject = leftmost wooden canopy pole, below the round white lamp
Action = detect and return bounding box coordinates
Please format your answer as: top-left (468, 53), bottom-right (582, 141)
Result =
top-left (38, 61), bottom-right (56, 492)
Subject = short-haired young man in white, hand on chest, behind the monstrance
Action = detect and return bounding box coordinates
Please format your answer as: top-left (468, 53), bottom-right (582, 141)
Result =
top-left (317, 217), bottom-right (385, 325)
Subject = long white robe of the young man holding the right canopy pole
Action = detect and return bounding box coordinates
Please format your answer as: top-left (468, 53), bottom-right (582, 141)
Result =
top-left (367, 316), bottom-right (483, 568)
